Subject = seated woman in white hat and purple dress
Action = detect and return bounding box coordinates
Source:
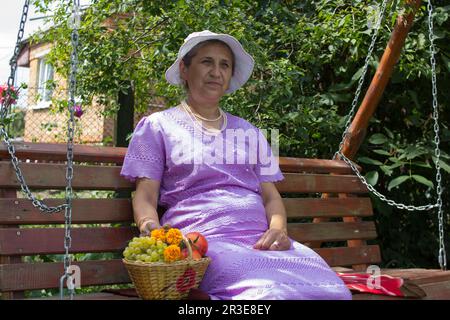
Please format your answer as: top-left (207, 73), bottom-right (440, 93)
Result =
top-left (121, 30), bottom-right (351, 300)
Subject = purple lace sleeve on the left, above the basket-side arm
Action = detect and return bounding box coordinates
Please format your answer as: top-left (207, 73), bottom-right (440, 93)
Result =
top-left (120, 114), bottom-right (165, 182)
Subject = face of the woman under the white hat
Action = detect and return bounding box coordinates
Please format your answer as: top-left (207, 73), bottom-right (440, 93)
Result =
top-left (180, 43), bottom-right (233, 102)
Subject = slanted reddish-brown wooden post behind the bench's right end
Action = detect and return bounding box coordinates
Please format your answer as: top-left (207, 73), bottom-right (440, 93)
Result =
top-left (307, 0), bottom-right (421, 258)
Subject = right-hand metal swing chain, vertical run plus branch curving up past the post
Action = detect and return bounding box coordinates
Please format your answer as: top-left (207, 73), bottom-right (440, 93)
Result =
top-left (333, 0), bottom-right (447, 270)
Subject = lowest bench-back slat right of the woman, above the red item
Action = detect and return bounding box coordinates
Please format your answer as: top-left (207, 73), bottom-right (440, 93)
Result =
top-left (314, 245), bottom-right (381, 267)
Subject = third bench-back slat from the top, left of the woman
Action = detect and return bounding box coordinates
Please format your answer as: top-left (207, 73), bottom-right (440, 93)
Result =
top-left (0, 198), bottom-right (133, 225)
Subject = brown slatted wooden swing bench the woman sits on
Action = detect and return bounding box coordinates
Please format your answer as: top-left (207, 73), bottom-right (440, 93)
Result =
top-left (0, 143), bottom-right (450, 299)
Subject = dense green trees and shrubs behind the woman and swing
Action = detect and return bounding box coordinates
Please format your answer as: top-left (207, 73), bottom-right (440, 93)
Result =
top-left (29, 0), bottom-right (450, 267)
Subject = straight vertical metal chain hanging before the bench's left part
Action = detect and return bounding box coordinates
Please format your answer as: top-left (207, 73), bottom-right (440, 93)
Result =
top-left (59, 0), bottom-right (80, 300)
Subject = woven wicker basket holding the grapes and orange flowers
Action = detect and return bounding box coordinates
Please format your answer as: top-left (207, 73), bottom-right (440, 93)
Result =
top-left (122, 237), bottom-right (211, 300)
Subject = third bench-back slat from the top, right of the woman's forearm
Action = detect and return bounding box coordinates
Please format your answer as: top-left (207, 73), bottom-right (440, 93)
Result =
top-left (283, 198), bottom-right (373, 218)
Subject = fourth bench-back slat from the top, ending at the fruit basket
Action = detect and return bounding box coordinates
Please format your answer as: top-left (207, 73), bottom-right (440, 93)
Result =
top-left (0, 227), bottom-right (138, 255)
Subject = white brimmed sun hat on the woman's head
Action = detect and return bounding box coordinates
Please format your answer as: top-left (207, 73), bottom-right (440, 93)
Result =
top-left (166, 30), bottom-right (255, 93)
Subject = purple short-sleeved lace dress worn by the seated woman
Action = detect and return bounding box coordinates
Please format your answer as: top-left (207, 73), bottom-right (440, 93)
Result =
top-left (121, 107), bottom-right (351, 300)
